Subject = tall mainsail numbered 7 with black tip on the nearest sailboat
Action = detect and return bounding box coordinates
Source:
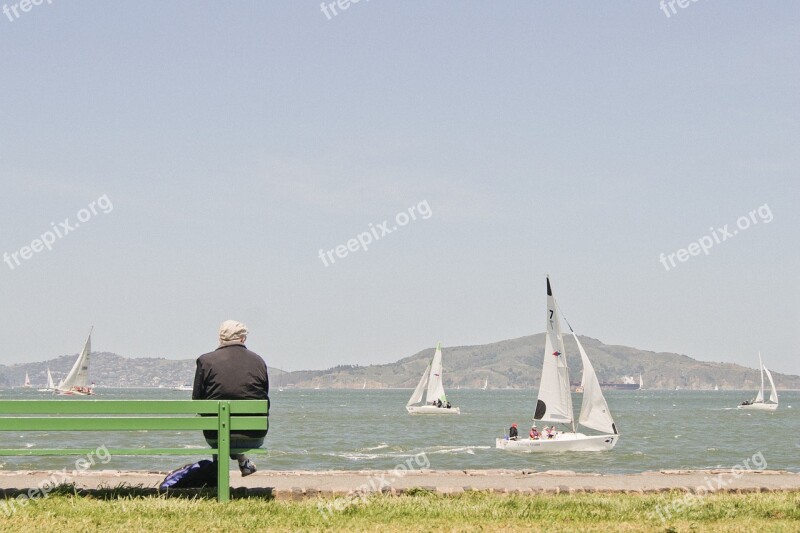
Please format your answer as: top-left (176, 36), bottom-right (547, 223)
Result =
top-left (533, 277), bottom-right (573, 424)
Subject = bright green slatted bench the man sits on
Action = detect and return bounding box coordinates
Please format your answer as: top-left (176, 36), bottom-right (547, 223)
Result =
top-left (0, 399), bottom-right (269, 502)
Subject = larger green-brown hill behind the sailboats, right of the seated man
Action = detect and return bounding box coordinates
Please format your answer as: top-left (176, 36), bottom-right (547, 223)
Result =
top-left (287, 333), bottom-right (800, 390)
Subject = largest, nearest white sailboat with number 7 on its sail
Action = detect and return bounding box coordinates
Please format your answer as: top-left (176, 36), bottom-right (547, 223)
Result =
top-left (495, 276), bottom-right (619, 453)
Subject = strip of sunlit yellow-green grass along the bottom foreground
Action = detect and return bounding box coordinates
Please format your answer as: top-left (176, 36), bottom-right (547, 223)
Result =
top-left (0, 490), bottom-right (800, 533)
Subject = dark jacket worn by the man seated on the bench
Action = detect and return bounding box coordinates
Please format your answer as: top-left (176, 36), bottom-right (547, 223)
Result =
top-left (192, 344), bottom-right (269, 439)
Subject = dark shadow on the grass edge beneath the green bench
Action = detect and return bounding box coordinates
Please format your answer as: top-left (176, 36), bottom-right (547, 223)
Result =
top-left (0, 482), bottom-right (275, 501)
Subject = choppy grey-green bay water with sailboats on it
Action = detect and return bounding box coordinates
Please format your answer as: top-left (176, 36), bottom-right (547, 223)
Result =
top-left (0, 389), bottom-right (800, 473)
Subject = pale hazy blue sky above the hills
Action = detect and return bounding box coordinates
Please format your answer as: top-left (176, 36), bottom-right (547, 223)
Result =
top-left (0, 0), bottom-right (800, 374)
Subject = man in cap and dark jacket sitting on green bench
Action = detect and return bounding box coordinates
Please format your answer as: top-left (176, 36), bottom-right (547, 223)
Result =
top-left (192, 320), bottom-right (269, 476)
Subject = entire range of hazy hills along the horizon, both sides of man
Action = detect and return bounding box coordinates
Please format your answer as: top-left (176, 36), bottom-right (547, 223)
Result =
top-left (0, 333), bottom-right (800, 390)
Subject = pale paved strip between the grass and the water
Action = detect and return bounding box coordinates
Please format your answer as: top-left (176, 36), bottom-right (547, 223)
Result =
top-left (0, 470), bottom-right (800, 499)
